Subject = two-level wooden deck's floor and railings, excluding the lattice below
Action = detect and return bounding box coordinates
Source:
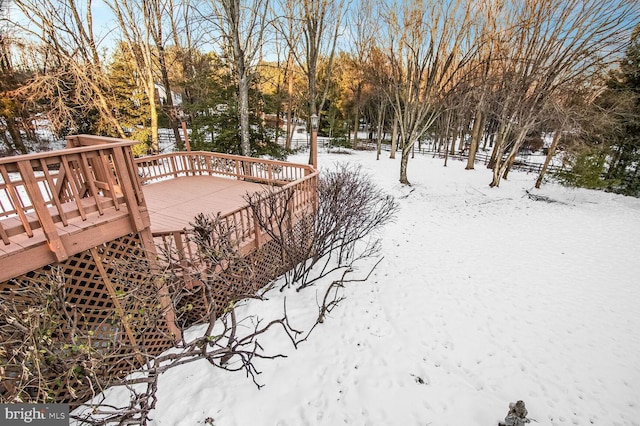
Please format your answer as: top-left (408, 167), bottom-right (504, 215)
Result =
top-left (0, 135), bottom-right (318, 283)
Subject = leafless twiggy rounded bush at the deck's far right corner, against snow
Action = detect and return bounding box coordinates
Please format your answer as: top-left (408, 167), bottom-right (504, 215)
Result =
top-left (246, 164), bottom-right (398, 290)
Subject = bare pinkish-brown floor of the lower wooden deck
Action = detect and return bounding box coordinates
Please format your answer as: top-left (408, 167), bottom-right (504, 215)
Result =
top-left (142, 176), bottom-right (267, 233)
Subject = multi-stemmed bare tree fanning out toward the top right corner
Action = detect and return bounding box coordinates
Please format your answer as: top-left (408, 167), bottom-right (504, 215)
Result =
top-left (484, 0), bottom-right (640, 187)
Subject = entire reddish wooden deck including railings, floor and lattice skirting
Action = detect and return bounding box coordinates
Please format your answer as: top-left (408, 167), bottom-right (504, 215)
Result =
top-left (0, 135), bottom-right (318, 404)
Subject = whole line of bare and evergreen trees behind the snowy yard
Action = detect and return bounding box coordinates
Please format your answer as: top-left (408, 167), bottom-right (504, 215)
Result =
top-left (0, 0), bottom-right (640, 194)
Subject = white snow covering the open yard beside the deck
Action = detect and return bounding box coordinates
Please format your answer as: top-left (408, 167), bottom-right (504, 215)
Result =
top-left (72, 151), bottom-right (640, 426)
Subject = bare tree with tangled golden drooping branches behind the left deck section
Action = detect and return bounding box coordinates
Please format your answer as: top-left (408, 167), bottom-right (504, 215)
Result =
top-left (8, 0), bottom-right (125, 138)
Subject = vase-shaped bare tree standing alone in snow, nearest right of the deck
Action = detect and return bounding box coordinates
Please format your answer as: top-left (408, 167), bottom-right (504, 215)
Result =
top-left (379, 0), bottom-right (474, 184)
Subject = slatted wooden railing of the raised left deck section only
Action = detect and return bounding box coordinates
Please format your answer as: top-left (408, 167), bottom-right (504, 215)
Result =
top-left (0, 139), bottom-right (147, 274)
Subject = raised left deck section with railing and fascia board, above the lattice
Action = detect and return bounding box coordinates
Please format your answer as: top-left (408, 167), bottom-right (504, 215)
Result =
top-left (0, 139), bottom-right (149, 282)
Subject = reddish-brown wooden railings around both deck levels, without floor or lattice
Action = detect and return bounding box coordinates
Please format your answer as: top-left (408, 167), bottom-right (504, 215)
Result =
top-left (0, 135), bottom-right (318, 279)
